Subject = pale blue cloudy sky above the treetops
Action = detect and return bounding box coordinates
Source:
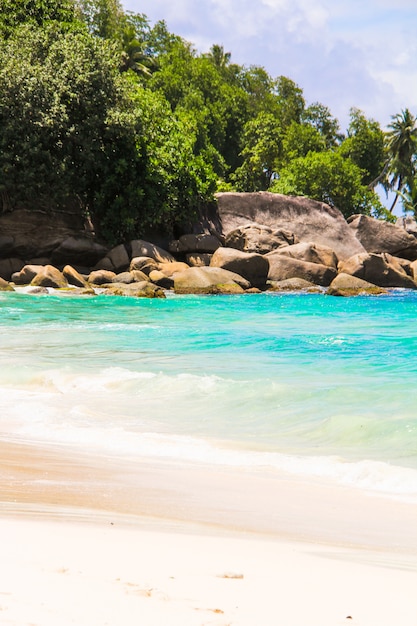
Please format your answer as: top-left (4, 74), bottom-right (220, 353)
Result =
top-left (122, 0), bottom-right (417, 131)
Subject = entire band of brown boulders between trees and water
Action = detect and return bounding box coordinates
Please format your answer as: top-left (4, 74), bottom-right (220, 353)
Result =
top-left (0, 192), bottom-right (417, 298)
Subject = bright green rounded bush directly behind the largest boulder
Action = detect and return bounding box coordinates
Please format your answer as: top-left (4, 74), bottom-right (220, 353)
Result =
top-left (271, 151), bottom-right (382, 217)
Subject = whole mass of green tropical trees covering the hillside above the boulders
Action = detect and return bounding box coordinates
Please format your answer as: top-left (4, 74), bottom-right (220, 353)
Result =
top-left (0, 0), bottom-right (417, 242)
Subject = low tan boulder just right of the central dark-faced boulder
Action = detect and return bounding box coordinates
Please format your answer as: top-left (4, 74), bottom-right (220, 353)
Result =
top-left (267, 252), bottom-right (337, 287)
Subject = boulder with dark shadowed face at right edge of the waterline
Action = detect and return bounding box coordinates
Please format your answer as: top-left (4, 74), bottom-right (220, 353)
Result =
top-left (338, 252), bottom-right (417, 289)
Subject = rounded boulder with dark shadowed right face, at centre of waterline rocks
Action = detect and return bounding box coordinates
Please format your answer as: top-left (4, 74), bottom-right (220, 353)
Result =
top-left (210, 248), bottom-right (269, 288)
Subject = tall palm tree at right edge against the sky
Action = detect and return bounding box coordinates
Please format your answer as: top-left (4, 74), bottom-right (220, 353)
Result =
top-left (387, 109), bottom-right (417, 213)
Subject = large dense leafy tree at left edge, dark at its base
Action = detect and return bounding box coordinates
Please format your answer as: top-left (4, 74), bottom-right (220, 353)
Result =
top-left (0, 25), bottom-right (140, 219)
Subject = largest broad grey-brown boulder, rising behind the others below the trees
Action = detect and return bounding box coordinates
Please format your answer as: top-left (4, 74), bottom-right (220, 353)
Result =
top-left (216, 192), bottom-right (364, 259)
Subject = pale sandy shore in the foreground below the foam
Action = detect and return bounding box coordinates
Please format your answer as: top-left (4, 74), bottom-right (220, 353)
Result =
top-left (0, 441), bottom-right (417, 626)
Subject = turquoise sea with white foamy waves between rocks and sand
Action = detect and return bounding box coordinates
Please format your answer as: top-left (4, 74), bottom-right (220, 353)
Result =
top-left (0, 291), bottom-right (417, 498)
